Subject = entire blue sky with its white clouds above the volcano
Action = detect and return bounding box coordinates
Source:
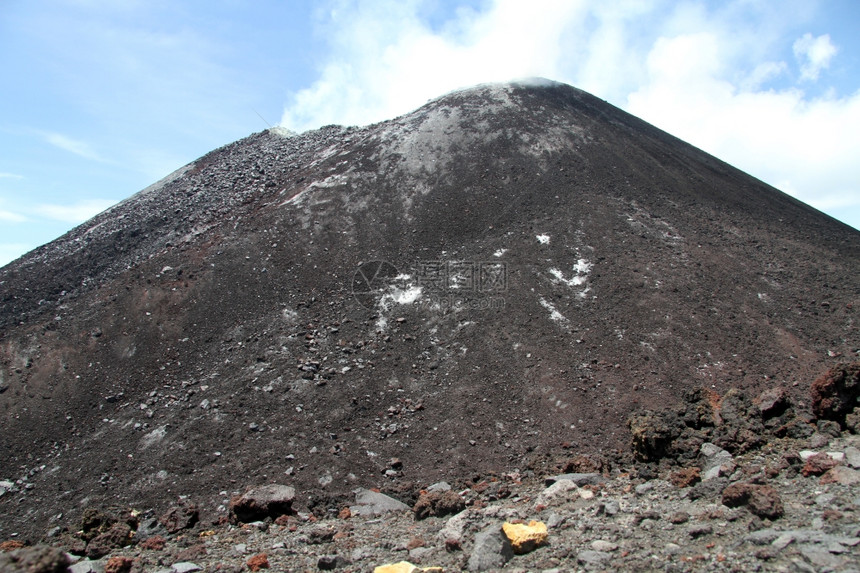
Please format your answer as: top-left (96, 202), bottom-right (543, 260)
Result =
top-left (0, 0), bottom-right (860, 264)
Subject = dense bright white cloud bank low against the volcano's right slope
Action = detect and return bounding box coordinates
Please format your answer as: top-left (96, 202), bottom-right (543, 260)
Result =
top-left (626, 30), bottom-right (860, 217)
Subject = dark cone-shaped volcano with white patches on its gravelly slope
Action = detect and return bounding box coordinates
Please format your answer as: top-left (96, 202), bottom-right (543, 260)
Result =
top-left (0, 80), bottom-right (860, 538)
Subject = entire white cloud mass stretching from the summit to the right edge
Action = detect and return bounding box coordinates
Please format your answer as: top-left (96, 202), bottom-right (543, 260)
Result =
top-left (282, 0), bottom-right (860, 227)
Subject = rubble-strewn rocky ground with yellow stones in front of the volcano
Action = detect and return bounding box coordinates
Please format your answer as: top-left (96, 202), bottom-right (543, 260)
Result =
top-left (0, 363), bottom-right (860, 573)
